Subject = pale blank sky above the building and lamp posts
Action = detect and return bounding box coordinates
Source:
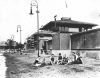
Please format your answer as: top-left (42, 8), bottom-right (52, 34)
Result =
top-left (0, 0), bottom-right (100, 43)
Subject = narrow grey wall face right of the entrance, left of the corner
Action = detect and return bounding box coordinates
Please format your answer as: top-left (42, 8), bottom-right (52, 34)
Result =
top-left (52, 34), bottom-right (60, 50)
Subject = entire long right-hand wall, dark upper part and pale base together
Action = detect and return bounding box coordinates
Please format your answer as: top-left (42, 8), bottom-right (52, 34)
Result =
top-left (71, 29), bottom-right (100, 59)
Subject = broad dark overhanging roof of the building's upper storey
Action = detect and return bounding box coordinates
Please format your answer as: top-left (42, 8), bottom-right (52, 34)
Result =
top-left (40, 20), bottom-right (97, 30)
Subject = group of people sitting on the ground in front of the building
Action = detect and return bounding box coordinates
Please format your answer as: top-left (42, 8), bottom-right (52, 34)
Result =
top-left (34, 52), bottom-right (82, 66)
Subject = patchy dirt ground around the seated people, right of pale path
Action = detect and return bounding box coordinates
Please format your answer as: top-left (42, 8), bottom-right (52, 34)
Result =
top-left (4, 53), bottom-right (100, 78)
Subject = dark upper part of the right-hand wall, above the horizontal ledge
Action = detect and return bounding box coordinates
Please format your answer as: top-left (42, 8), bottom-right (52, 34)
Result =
top-left (71, 30), bottom-right (100, 49)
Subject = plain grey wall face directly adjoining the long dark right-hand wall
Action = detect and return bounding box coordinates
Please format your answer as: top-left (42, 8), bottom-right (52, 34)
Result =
top-left (60, 33), bottom-right (70, 50)
